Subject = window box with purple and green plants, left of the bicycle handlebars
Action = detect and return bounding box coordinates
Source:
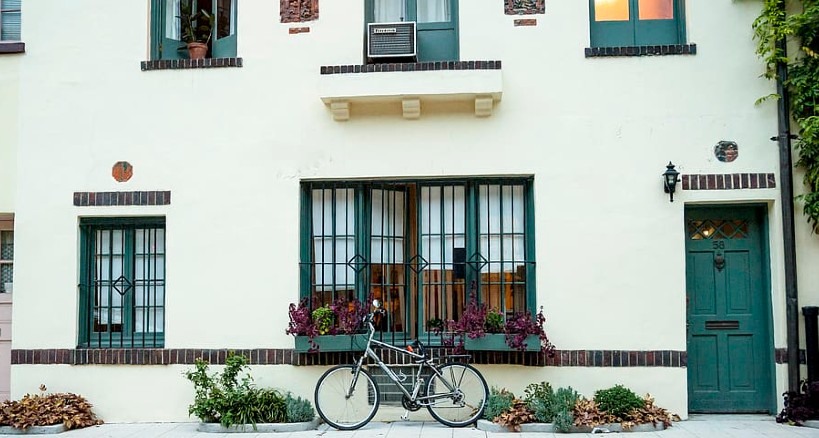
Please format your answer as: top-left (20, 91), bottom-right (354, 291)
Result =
top-left (286, 297), bottom-right (367, 353)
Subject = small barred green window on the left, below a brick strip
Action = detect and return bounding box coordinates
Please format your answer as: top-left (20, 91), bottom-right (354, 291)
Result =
top-left (78, 217), bottom-right (165, 348)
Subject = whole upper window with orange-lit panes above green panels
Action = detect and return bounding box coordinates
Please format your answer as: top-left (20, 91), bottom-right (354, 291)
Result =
top-left (589, 0), bottom-right (685, 47)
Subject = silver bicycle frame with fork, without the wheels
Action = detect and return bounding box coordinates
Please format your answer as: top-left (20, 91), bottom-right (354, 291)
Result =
top-left (347, 314), bottom-right (457, 406)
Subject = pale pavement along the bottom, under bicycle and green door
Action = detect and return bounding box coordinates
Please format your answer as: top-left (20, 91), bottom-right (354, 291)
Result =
top-left (9, 415), bottom-right (819, 438)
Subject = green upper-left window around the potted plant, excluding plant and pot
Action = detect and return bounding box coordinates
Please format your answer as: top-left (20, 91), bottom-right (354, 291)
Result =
top-left (151, 0), bottom-right (238, 60)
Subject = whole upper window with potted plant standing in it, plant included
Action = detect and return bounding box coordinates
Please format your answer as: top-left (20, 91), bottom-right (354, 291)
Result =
top-left (151, 0), bottom-right (238, 60)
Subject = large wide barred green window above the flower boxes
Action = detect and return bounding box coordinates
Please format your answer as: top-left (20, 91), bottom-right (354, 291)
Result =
top-left (299, 177), bottom-right (536, 338)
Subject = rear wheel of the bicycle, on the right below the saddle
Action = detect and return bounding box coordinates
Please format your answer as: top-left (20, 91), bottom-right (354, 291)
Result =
top-left (427, 363), bottom-right (489, 427)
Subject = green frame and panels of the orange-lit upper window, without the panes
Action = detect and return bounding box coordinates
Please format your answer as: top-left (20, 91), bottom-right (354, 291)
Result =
top-left (589, 0), bottom-right (685, 47)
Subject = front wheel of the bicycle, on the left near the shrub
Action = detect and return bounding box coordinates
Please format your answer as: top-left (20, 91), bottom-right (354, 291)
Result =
top-left (315, 365), bottom-right (380, 430)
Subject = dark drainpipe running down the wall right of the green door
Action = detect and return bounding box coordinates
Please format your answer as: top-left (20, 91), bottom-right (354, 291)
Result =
top-left (776, 0), bottom-right (799, 391)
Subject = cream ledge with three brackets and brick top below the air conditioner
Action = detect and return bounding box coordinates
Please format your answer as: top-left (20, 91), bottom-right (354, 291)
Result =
top-left (320, 61), bottom-right (503, 121)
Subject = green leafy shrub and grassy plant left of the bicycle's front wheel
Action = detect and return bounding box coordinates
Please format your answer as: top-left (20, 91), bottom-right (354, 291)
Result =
top-left (183, 353), bottom-right (296, 428)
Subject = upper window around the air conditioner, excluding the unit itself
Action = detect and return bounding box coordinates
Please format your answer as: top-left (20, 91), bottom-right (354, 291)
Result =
top-left (364, 0), bottom-right (458, 62)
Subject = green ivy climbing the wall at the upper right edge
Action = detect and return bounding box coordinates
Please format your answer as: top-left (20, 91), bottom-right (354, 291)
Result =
top-left (753, 0), bottom-right (819, 231)
